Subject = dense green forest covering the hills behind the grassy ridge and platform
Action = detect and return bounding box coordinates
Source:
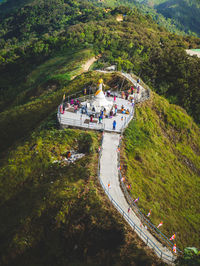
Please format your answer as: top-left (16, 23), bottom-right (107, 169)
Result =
top-left (0, 0), bottom-right (200, 126)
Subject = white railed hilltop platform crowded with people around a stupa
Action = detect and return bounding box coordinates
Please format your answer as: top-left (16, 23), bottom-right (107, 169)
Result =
top-left (57, 74), bottom-right (149, 133)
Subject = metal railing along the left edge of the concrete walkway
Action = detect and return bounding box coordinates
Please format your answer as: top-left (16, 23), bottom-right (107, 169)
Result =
top-left (97, 133), bottom-right (176, 263)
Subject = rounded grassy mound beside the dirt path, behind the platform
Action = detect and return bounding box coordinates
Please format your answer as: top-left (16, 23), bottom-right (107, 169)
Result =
top-left (12, 49), bottom-right (94, 108)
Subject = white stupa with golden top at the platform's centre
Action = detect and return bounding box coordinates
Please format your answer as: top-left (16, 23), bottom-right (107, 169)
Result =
top-left (90, 79), bottom-right (113, 112)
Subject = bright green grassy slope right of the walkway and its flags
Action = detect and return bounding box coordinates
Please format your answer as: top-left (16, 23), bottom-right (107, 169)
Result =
top-left (124, 94), bottom-right (200, 248)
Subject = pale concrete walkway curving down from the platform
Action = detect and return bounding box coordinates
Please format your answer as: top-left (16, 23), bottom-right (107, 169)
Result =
top-left (100, 133), bottom-right (173, 263)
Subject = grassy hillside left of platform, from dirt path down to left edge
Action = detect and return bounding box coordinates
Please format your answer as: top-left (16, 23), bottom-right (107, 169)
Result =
top-left (0, 50), bottom-right (93, 154)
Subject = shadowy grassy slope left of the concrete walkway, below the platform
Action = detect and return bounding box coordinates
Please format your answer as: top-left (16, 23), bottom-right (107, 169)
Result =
top-left (0, 121), bottom-right (160, 266)
